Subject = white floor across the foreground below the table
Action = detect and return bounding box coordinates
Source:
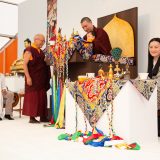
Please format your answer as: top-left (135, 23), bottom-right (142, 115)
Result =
top-left (0, 112), bottom-right (160, 160)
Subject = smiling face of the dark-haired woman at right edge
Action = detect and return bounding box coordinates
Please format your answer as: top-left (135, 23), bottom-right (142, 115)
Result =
top-left (149, 41), bottom-right (160, 57)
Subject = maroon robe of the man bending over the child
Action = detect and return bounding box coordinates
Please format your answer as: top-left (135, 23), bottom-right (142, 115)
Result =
top-left (84, 27), bottom-right (112, 55)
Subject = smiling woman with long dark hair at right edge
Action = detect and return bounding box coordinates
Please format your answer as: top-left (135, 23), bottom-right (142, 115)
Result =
top-left (148, 38), bottom-right (160, 136)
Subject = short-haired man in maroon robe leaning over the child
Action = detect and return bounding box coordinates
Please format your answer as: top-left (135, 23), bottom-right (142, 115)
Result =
top-left (81, 17), bottom-right (112, 57)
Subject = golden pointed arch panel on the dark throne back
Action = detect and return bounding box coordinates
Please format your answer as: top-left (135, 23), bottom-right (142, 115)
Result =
top-left (104, 15), bottom-right (134, 57)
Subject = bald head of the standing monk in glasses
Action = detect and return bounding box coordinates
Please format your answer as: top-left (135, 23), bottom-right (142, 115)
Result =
top-left (34, 34), bottom-right (45, 49)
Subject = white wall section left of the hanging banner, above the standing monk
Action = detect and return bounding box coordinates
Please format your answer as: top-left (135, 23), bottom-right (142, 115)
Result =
top-left (18, 0), bottom-right (47, 57)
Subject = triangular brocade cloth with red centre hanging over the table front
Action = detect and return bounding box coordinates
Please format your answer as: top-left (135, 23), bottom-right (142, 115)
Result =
top-left (68, 78), bottom-right (112, 127)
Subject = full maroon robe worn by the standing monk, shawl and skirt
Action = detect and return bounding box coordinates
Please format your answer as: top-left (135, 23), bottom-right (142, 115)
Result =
top-left (23, 47), bottom-right (51, 117)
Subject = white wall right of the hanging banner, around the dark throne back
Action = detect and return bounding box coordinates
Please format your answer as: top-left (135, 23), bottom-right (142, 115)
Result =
top-left (58, 0), bottom-right (160, 72)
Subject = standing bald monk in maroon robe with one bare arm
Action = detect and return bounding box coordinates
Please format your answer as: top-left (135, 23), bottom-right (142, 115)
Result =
top-left (23, 34), bottom-right (50, 123)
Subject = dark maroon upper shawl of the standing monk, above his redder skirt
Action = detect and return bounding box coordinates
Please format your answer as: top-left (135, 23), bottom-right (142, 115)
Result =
top-left (25, 47), bottom-right (51, 92)
